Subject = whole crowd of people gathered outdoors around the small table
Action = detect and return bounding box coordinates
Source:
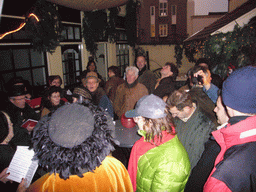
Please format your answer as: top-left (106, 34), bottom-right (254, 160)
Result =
top-left (0, 55), bottom-right (256, 192)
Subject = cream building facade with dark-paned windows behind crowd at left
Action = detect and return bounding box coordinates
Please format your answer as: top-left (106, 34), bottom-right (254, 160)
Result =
top-left (0, 0), bottom-right (133, 92)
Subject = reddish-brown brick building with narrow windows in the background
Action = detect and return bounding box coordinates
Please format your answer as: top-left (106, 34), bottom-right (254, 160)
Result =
top-left (137, 0), bottom-right (187, 45)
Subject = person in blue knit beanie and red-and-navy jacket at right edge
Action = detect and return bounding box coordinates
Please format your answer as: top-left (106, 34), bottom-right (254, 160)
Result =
top-left (204, 66), bottom-right (256, 192)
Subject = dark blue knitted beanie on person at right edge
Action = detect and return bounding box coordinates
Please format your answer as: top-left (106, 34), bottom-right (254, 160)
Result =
top-left (222, 66), bottom-right (256, 113)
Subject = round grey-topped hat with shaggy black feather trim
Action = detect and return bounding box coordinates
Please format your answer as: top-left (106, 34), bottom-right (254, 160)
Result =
top-left (32, 103), bottom-right (119, 179)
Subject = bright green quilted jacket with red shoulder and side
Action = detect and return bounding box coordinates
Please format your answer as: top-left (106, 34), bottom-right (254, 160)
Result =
top-left (128, 131), bottom-right (190, 192)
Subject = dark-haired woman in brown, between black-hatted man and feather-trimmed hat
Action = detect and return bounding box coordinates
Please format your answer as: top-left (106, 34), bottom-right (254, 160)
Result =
top-left (41, 86), bottom-right (65, 117)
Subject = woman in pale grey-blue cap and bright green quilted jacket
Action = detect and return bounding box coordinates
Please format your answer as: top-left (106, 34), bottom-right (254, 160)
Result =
top-left (125, 94), bottom-right (190, 192)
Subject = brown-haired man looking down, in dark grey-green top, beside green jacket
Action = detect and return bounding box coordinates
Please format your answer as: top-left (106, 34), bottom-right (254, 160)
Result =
top-left (167, 91), bottom-right (217, 169)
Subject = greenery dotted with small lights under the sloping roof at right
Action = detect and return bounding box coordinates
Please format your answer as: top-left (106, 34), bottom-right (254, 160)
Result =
top-left (184, 17), bottom-right (256, 78)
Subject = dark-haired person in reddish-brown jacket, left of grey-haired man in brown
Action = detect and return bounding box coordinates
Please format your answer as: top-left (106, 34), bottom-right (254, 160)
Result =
top-left (105, 66), bottom-right (124, 103)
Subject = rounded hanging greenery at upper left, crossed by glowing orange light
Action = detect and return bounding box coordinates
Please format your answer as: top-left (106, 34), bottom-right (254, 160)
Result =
top-left (25, 0), bottom-right (62, 54)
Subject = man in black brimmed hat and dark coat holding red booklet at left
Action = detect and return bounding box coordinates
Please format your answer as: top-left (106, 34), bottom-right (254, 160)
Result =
top-left (5, 85), bottom-right (40, 145)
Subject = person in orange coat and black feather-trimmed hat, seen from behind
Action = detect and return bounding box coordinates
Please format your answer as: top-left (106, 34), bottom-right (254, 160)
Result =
top-left (28, 103), bottom-right (132, 192)
